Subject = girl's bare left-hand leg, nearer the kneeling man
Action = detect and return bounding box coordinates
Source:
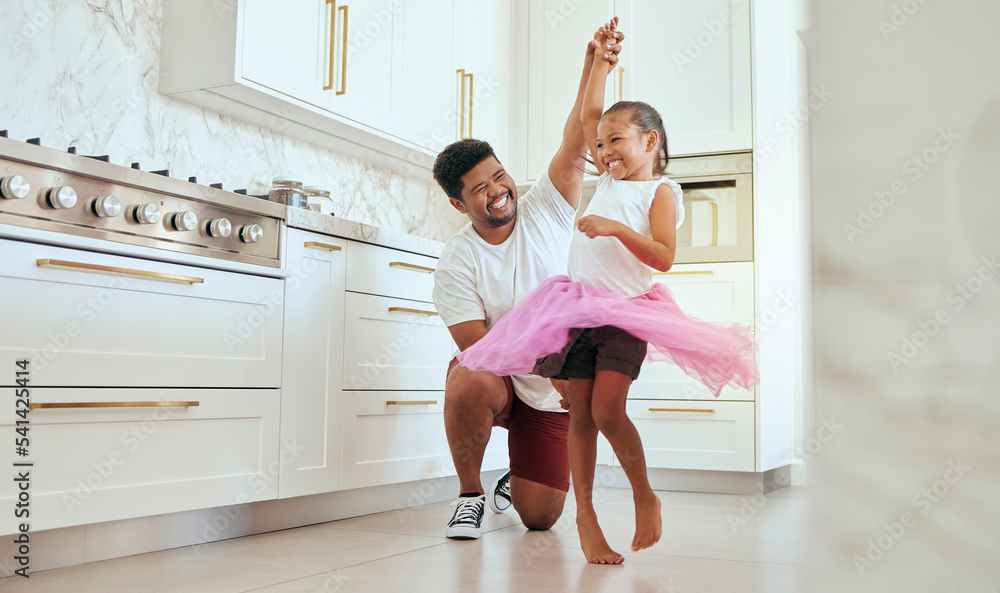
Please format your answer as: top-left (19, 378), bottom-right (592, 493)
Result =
top-left (567, 379), bottom-right (625, 564)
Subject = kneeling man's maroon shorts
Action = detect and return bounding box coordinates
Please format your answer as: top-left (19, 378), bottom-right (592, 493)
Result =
top-left (448, 359), bottom-right (569, 492)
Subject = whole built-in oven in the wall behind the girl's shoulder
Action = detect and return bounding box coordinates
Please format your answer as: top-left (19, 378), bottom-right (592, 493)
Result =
top-left (667, 153), bottom-right (753, 263)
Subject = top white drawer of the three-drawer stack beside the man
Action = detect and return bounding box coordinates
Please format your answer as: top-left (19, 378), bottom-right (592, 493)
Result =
top-left (347, 241), bottom-right (437, 303)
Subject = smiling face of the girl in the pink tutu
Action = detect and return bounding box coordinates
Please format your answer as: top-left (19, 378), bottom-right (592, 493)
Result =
top-left (594, 112), bottom-right (659, 181)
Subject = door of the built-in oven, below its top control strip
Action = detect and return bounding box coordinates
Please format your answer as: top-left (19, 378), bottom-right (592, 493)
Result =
top-left (674, 174), bottom-right (753, 263)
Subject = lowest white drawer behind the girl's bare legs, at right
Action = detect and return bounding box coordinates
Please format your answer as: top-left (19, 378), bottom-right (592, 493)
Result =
top-left (625, 400), bottom-right (755, 472)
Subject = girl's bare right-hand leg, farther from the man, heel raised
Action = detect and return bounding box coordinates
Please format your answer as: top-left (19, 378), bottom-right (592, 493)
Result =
top-left (588, 371), bottom-right (662, 550)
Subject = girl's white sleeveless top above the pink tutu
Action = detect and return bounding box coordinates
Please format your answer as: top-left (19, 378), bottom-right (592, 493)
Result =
top-left (569, 173), bottom-right (684, 297)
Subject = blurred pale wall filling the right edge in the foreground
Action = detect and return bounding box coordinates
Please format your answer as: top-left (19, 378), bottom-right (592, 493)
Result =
top-left (806, 0), bottom-right (1000, 593)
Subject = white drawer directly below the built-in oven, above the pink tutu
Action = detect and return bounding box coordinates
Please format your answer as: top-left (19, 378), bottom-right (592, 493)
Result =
top-left (653, 262), bottom-right (754, 329)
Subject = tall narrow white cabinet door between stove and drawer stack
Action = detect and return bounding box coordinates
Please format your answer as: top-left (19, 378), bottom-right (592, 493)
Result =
top-left (279, 229), bottom-right (347, 498)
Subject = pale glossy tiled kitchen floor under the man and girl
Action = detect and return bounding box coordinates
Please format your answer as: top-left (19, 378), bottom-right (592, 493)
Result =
top-left (0, 488), bottom-right (807, 593)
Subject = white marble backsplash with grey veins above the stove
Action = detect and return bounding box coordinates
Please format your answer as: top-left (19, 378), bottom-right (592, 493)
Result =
top-left (0, 0), bottom-right (467, 241)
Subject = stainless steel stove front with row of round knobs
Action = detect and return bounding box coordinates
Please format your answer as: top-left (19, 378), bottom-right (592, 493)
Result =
top-left (0, 131), bottom-right (285, 268)
